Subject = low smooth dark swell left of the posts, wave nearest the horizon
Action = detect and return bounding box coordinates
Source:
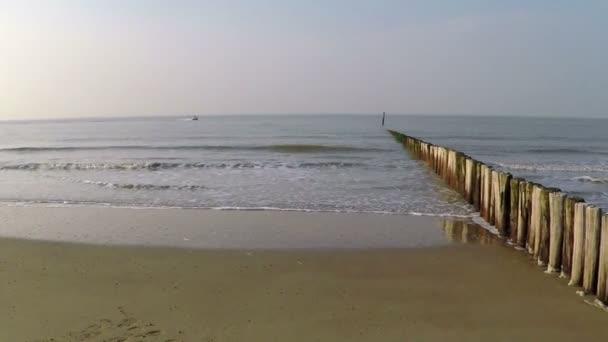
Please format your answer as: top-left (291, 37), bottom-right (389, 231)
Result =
top-left (0, 144), bottom-right (389, 153)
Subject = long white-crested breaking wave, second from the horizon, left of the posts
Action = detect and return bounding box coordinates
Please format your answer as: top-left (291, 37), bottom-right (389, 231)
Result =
top-left (0, 161), bottom-right (370, 171)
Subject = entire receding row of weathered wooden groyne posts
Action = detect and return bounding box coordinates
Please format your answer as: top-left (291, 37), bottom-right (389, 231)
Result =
top-left (389, 131), bottom-right (608, 303)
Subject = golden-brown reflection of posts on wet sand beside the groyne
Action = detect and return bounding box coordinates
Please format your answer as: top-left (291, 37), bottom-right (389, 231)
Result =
top-left (440, 220), bottom-right (504, 245)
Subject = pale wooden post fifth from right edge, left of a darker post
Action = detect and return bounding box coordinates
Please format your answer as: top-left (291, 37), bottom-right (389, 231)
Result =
top-left (547, 192), bottom-right (566, 273)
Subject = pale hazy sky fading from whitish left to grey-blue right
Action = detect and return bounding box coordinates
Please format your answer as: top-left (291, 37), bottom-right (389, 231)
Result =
top-left (0, 0), bottom-right (608, 119)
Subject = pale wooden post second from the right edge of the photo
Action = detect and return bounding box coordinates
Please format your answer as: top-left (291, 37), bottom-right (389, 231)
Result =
top-left (583, 207), bottom-right (601, 294)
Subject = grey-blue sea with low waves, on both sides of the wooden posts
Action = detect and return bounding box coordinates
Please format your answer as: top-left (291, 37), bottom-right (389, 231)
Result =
top-left (0, 114), bottom-right (608, 217)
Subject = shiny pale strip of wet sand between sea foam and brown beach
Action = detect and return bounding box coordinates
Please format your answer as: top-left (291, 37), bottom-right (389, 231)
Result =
top-left (0, 207), bottom-right (474, 249)
